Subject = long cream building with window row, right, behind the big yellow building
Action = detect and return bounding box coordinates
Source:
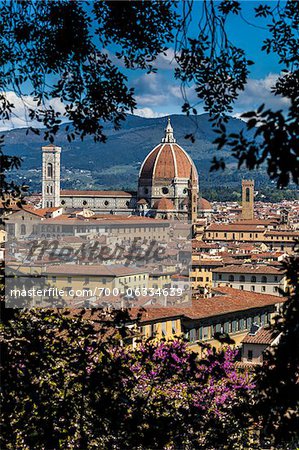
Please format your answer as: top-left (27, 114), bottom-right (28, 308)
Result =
top-left (212, 264), bottom-right (287, 296)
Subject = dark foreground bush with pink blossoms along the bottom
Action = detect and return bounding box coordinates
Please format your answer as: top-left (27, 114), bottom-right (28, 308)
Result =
top-left (1, 310), bottom-right (253, 449)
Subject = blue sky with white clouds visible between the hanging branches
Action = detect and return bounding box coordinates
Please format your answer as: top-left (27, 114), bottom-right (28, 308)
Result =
top-left (0, 0), bottom-right (288, 130)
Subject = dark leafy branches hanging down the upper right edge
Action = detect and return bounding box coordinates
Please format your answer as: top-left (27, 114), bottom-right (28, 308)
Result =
top-left (213, 1), bottom-right (299, 187)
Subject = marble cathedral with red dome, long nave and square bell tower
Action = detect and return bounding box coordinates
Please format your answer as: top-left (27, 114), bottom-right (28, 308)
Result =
top-left (42, 119), bottom-right (210, 223)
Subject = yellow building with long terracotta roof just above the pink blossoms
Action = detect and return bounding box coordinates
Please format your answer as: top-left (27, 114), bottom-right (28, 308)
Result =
top-left (131, 287), bottom-right (285, 354)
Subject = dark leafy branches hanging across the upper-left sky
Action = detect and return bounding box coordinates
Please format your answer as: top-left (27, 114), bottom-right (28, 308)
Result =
top-left (0, 0), bottom-right (176, 142)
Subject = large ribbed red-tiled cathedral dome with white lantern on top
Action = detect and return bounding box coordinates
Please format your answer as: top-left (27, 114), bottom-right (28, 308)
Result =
top-left (139, 119), bottom-right (198, 182)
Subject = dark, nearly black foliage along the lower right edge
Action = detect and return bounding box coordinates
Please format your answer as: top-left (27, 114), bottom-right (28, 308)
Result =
top-left (254, 252), bottom-right (299, 448)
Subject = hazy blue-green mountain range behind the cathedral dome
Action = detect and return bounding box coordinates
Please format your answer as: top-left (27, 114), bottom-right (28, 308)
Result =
top-left (5, 114), bottom-right (270, 190)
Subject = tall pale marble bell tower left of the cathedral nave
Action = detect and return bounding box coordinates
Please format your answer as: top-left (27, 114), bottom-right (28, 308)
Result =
top-left (42, 145), bottom-right (61, 208)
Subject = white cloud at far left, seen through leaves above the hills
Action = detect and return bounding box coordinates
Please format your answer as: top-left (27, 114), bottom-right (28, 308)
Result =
top-left (0, 91), bottom-right (65, 131)
